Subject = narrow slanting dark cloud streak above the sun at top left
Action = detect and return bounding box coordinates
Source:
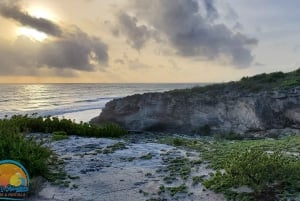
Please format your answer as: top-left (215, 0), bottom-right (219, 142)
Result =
top-left (0, 3), bottom-right (62, 36)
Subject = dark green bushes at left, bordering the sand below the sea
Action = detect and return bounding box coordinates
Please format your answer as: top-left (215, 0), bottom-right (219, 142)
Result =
top-left (0, 114), bottom-right (127, 187)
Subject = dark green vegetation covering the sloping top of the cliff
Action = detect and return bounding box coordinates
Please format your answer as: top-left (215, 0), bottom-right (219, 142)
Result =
top-left (166, 68), bottom-right (300, 95)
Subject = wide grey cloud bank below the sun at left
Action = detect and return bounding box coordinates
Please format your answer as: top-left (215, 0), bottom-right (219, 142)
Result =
top-left (0, 30), bottom-right (108, 75)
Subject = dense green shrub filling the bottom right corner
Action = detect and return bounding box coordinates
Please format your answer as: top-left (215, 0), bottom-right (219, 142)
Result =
top-left (203, 149), bottom-right (300, 200)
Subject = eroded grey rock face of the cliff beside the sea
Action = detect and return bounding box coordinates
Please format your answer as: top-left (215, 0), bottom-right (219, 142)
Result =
top-left (93, 87), bottom-right (300, 133)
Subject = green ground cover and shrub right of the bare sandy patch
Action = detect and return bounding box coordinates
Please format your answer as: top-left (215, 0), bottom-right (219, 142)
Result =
top-left (160, 135), bottom-right (300, 200)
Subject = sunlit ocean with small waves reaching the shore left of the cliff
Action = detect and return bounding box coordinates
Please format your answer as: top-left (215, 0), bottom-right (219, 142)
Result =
top-left (0, 83), bottom-right (204, 122)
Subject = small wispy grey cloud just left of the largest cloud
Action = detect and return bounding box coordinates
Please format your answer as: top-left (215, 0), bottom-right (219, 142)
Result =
top-left (119, 13), bottom-right (152, 50)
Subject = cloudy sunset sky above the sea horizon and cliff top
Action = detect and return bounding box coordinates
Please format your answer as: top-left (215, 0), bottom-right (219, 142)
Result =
top-left (0, 0), bottom-right (300, 83)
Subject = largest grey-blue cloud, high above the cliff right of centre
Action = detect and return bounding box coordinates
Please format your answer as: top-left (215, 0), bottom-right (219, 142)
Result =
top-left (119, 0), bottom-right (258, 67)
